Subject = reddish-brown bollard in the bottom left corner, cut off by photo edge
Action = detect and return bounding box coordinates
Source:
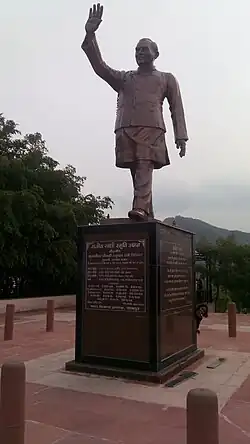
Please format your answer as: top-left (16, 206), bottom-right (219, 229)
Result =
top-left (0, 362), bottom-right (26, 444)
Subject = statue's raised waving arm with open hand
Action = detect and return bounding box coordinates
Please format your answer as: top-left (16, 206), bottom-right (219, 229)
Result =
top-left (81, 3), bottom-right (124, 92)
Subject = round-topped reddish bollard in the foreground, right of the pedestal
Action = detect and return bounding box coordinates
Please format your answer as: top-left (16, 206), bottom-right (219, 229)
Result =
top-left (186, 389), bottom-right (219, 444)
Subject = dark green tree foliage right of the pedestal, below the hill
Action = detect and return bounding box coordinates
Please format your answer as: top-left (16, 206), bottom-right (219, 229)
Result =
top-left (197, 236), bottom-right (250, 312)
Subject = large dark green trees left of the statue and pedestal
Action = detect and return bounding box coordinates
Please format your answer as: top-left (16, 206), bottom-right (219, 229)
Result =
top-left (0, 114), bottom-right (112, 297)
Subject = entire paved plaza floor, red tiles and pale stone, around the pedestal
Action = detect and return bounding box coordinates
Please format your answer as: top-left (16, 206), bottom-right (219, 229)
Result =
top-left (0, 311), bottom-right (250, 444)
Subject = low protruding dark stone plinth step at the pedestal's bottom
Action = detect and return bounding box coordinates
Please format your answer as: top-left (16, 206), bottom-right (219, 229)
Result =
top-left (65, 349), bottom-right (204, 384)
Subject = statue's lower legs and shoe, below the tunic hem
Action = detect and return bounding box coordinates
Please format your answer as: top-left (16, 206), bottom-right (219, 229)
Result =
top-left (130, 160), bottom-right (154, 218)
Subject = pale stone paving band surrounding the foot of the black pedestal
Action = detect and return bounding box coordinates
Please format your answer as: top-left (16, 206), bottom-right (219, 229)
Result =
top-left (27, 349), bottom-right (250, 408)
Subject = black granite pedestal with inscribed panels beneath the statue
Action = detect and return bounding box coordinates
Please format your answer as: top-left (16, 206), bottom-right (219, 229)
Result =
top-left (66, 219), bottom-right (204, 383)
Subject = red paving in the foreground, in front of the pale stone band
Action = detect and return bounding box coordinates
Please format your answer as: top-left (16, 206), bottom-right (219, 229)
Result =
top-left (23, 379), bottom-right (250, 444)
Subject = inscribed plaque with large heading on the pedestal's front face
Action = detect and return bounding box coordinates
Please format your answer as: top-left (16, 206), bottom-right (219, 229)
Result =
top-left (85, 239), bottom-right (146, 312)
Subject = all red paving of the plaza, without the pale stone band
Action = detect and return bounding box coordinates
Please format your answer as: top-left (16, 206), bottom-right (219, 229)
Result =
top-left (0, 315), bottom-right (250, 444)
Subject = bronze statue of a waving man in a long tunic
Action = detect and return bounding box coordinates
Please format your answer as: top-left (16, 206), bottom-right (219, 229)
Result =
top-left (82, 3), bottom-right (188, 220)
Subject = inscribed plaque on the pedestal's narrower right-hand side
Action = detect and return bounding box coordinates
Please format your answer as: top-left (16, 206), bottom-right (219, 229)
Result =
top-left (160, 228), bottom-right (193, 310)
